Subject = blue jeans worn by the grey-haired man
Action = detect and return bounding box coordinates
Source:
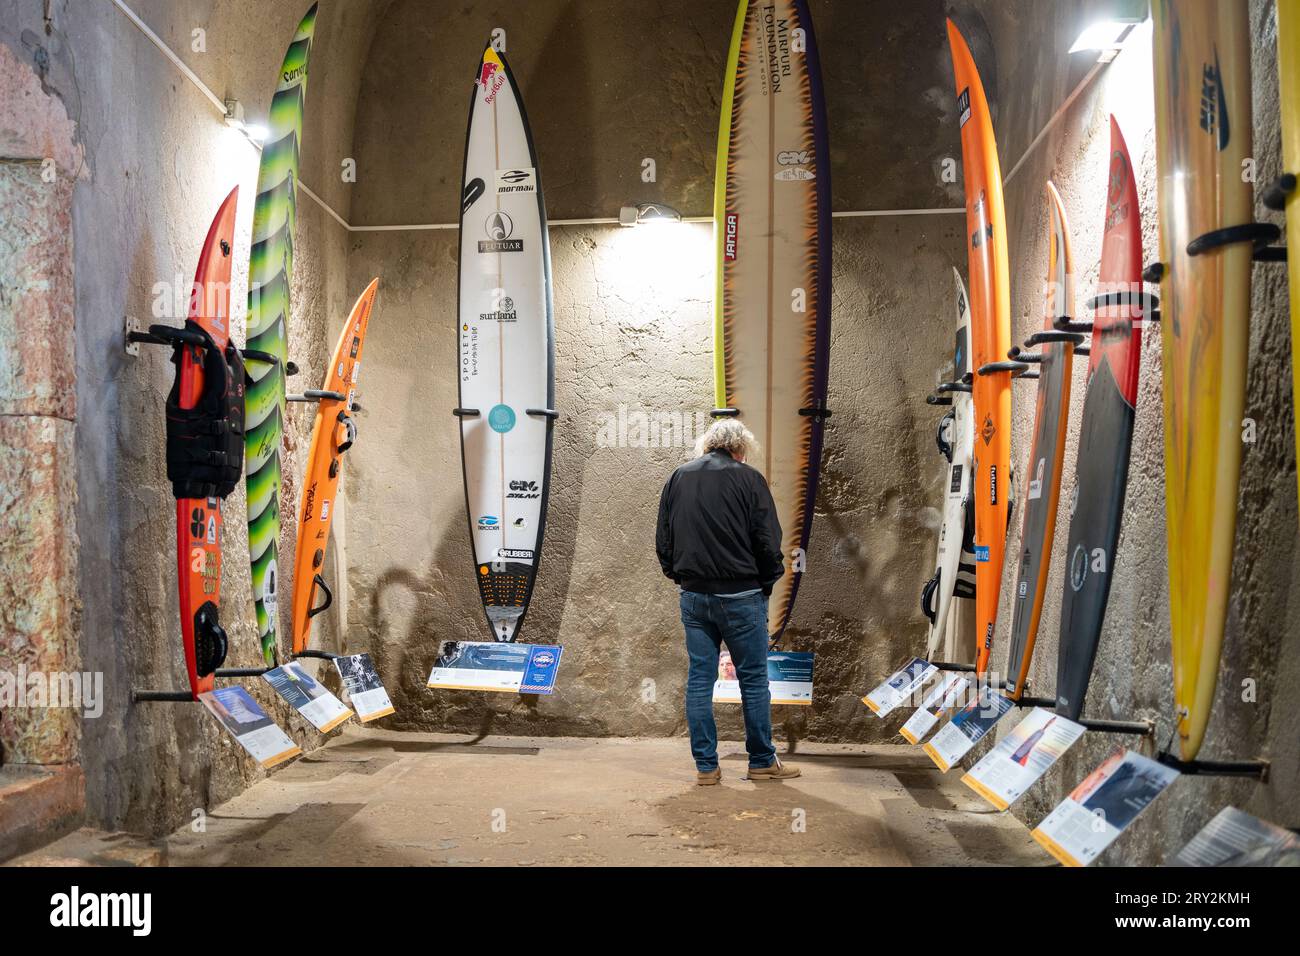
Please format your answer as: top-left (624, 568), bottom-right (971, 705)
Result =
top-left (681, 591), bottom-right (776, 773)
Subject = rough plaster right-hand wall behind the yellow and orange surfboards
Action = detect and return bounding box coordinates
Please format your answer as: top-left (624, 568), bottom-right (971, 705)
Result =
top-left (972, 3), bottom-right (1300, 864)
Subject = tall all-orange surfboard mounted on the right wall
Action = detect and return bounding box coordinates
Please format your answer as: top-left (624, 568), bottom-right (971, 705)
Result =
top-left (948, 20), bottom-right (1015, 674)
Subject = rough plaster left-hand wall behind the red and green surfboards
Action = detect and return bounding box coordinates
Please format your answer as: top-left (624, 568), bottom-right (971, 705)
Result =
top-left (0, 0), bottom-right (380, 831)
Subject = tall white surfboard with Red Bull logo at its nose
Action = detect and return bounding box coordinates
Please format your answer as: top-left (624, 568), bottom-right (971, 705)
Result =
top-left (456, 46), bottom-right (555, 641)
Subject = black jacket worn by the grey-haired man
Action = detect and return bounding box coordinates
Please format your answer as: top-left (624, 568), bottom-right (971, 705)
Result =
top-left (655, 451), bottom-right (785, 594)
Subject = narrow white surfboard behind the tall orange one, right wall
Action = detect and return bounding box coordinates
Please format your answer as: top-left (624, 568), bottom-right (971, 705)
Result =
top-left (923, 269), bottom-right (975, 663)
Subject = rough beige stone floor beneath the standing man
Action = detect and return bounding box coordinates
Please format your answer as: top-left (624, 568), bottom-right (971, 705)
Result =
top-left (14, 728), bottom-right (1050, 866)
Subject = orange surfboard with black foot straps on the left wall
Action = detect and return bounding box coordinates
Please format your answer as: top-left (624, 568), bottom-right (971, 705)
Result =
top-left (293, 278), bottom-right (380, 654)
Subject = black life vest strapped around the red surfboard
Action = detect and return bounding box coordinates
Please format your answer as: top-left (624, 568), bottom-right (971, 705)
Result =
top-left (166, 320), bottom-right (244, 498)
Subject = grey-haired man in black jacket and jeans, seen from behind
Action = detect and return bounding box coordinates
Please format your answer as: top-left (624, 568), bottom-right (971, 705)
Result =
top-left (655, 419), bottom-right (800, 787)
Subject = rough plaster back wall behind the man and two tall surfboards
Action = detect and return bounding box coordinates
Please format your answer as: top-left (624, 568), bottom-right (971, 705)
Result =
top-left (345, 0), bottom-right (965, 740)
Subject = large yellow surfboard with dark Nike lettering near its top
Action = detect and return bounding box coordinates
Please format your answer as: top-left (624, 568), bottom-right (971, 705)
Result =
top-left (1152, 0), bottom-right (1253, 760)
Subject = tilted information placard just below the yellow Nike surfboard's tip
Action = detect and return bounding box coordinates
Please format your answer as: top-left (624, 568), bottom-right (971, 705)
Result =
top-left (1030, 747), bottom-right (1178, 866)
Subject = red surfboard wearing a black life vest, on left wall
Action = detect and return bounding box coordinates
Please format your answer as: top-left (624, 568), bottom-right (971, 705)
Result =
top-left (176, 186), bottom-right (243, 700)
